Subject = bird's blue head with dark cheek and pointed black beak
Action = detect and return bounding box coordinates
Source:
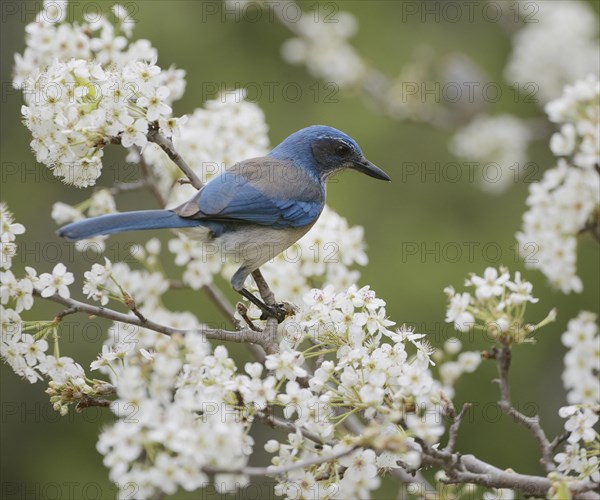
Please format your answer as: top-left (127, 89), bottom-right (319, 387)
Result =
top-left (269, 125), bottom-right (391, 181)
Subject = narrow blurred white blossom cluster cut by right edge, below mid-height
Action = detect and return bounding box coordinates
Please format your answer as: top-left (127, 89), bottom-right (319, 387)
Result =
top-left (561, 311), bottom-right (600, 404)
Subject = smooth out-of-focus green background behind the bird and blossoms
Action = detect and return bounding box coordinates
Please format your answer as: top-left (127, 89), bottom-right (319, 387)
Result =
top-left (0, 0), bottom-right (599, 499)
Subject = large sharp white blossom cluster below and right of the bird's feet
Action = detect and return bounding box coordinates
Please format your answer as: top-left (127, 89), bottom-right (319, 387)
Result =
top-left (255, 286), bottom-right (444, 498)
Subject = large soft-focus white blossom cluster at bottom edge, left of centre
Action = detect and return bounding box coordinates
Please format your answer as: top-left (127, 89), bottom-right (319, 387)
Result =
top-left (97, 338), bottom-right (253, 498)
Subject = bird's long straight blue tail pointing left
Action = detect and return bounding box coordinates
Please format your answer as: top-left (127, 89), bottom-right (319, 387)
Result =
top-left (57, 210), bottom-right (202, 241)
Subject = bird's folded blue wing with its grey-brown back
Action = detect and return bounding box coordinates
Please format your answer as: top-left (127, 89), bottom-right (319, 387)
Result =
top-left (176, 158), bottom-right (325, 228)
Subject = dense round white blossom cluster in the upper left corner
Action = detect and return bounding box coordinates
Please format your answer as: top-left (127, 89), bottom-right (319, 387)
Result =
top-left (13, 1), bottom-right (185, 187)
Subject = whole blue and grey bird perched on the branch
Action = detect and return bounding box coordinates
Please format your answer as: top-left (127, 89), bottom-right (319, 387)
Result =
top-left (58, 125), bottom-right (390, 320)
